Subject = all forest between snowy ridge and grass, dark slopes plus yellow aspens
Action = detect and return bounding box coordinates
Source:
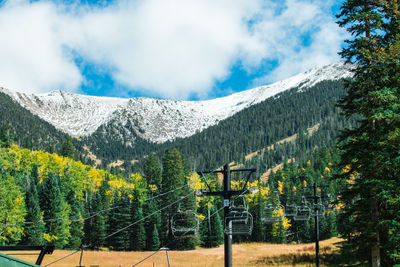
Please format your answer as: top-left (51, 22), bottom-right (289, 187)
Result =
top-left (0, 75), bottom-right (355, 253)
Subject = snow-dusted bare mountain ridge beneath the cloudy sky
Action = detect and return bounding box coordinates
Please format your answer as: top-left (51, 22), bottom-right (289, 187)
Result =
top-left (0, 62), bottom-right (351, 143)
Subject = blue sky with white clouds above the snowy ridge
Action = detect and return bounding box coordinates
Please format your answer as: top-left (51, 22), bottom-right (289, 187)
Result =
top-left (0, 0), bottom-right (347, 100)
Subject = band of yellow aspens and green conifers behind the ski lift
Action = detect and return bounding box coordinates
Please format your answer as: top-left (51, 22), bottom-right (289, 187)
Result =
top-left (0, 141), bottom-right (344, 250)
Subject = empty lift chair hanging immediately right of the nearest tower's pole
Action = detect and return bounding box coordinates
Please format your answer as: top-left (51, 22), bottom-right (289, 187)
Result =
top-left (225, 196), bottom-right (253, 235)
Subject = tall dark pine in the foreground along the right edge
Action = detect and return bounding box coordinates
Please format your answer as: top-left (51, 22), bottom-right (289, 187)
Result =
top-left (338, 0), bottom-right (400, 266)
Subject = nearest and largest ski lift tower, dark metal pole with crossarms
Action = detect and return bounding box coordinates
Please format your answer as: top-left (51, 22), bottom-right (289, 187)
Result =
top-left (198, 164), bottom-right (256, 267)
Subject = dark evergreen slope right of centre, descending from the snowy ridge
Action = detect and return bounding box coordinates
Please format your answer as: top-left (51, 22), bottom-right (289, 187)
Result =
top-left (142, 81), bottom-right (356, 172)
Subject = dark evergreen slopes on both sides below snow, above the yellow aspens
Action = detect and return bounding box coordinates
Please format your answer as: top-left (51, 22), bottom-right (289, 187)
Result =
top-left (0, 78), bottom-right (354, 178)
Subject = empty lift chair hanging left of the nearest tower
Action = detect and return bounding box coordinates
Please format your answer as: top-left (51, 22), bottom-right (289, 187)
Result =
top-left (171, 203), bottom-right (200, 236)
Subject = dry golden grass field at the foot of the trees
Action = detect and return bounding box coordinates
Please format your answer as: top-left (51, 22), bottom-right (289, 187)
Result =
top-left (2, 238), bottom-right (340, 267)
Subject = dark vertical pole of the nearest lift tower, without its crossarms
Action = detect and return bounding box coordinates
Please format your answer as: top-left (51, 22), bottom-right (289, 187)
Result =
top-left (223, 164), bottom-right (232, 267)
